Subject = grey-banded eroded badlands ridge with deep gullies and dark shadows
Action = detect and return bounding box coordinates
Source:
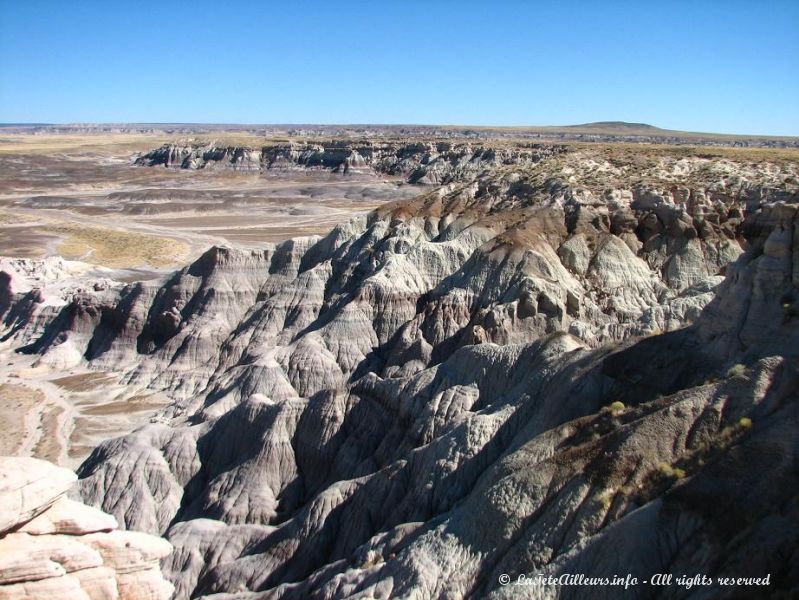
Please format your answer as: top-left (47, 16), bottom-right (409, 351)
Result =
top-left (0, 140), bottom-right (799, 600)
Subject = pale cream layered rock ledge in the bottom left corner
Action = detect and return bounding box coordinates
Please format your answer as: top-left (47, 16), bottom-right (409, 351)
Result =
top-left (0, 457), bottom-right (174, 600)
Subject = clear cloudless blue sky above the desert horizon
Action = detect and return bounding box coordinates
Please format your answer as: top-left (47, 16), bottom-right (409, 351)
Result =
top-left (0, 0), bottom-right (799, 135)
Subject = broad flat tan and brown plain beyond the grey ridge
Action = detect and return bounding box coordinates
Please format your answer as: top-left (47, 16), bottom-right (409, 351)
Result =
top-left (0, 133), bottom-right (419, 277)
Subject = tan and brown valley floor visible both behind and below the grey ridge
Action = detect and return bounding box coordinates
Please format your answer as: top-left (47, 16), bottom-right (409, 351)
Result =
top-left (0, 134), bottom-right (419, 468)
